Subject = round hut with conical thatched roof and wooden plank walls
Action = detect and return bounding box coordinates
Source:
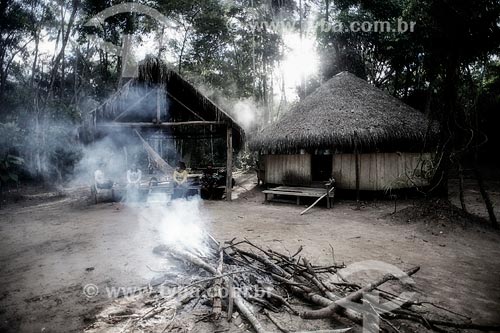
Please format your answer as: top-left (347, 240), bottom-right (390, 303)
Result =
top-left (250, 72), bottom-right (435, 190)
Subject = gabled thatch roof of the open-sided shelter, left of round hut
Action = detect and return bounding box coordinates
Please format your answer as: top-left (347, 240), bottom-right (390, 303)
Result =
top-left (90, 57), bottom-right (245, 149)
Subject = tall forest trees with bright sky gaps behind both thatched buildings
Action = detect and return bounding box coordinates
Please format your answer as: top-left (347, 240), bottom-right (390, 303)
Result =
top-left (0, 0), bottom-right (500, 200)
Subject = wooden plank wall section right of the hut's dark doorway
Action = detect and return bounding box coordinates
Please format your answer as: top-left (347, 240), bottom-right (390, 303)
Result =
top-left (332, 153), bottom-right (431, 190)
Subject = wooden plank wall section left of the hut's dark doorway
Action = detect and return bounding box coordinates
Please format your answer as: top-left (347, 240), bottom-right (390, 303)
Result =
top-left (264, 154), bottom-right (311, 185)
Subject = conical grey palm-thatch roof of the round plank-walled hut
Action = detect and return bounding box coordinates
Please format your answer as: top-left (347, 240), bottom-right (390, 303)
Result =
top-left (250, 72), bottom-right (436, 153)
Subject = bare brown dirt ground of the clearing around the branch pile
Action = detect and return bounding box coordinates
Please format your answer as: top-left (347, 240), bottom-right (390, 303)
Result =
top-left (0, 176), bottom-right (500, 332)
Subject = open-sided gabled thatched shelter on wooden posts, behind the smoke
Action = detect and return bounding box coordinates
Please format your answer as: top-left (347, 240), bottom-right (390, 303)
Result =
top-left (87, 58), bottom-right (244, 199)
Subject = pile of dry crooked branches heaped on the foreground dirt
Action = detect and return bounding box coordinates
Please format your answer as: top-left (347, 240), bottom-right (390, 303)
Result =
top-left (86, 238), bottom-right (500, 333)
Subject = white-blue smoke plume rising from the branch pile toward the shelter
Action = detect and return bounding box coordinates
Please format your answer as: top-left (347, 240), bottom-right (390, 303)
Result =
top-left (72, 120), bottom-right (209, 278)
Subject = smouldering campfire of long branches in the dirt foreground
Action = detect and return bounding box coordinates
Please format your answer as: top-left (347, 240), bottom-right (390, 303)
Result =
top-left (82, 236), bottom-right (498, 333)
